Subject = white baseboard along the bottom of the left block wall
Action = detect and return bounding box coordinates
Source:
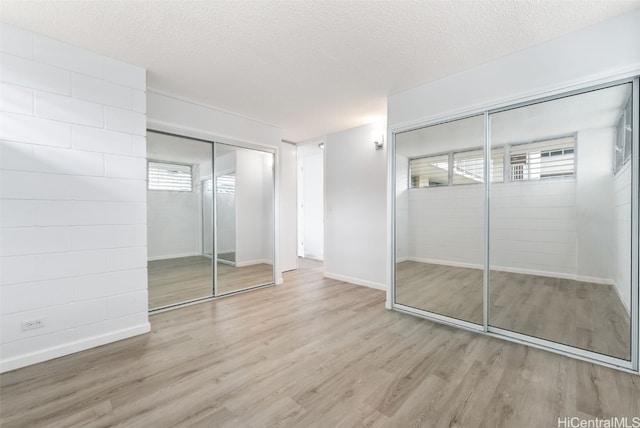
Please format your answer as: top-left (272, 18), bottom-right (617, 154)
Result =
top-left (0, 322), bottom-right (151, 373)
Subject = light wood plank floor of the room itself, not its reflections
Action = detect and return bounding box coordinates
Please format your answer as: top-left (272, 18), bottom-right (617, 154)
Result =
top-left (0, 265), bottom-right (640, 428)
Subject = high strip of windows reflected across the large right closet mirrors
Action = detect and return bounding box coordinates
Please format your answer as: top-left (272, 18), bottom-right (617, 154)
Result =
top-left (409, 136), bottom-right (575, 188)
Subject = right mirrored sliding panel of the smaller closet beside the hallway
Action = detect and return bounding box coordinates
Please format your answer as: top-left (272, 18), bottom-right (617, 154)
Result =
top-left (213, 143), bottom-right (274, 295)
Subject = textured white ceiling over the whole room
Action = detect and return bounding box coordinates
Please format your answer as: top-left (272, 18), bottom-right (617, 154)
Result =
top-left (0, 0), bottom-right (640, 142)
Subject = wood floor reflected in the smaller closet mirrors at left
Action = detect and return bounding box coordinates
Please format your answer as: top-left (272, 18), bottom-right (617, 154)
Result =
top-left (148, 256), bottom-right (273, 309)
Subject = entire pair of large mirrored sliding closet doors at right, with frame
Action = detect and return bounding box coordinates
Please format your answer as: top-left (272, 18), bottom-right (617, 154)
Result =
top-left (393, 79), bottom-right (638, 370)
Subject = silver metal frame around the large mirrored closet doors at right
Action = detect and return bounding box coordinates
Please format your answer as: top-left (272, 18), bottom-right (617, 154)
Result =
top-left (388, 73), bottom-right (640, 374)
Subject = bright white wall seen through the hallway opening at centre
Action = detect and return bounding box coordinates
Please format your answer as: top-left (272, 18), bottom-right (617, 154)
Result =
top-left (298, 141), bottom-right (324, 260)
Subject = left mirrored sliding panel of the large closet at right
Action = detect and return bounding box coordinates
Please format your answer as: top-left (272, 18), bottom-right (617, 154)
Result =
top-left (395, 115), bottom-right (484, 324)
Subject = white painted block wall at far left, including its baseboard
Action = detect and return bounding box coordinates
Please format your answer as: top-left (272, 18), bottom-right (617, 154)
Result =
top-left (0, 24), bottom-right (150, 371)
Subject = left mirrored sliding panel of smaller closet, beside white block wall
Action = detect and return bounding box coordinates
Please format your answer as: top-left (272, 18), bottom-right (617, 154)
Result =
top-left (147, 131), bottom-right (213, 310)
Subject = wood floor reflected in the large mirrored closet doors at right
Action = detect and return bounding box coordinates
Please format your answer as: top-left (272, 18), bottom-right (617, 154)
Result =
top-left (396, 261), bottom-right (631, 360)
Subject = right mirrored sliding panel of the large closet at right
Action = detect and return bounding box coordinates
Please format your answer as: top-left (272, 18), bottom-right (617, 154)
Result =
top-left (489, 83), bottom-right (637, 361)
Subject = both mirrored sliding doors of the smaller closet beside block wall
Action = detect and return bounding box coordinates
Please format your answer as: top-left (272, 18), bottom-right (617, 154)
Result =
top-left (147, 130), bottom-right (274, 310)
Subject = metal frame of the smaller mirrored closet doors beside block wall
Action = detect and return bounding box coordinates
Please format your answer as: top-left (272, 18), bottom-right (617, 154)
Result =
top-left (147, 128), bottom-right (277, 313)
